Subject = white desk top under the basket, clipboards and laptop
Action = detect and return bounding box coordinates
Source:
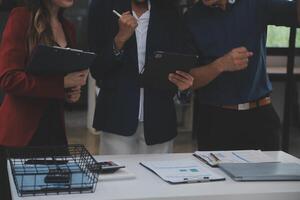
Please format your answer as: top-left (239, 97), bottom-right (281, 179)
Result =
top-left (10, 152), bottom-right (300, 200)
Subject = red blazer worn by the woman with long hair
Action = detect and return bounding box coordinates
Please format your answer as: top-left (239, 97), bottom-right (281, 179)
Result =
top-left (0, 7), bottom-right (75, 147)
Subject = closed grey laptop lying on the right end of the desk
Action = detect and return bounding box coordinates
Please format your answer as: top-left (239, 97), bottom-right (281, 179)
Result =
top-left (219, 162), bottom-right (300, 181)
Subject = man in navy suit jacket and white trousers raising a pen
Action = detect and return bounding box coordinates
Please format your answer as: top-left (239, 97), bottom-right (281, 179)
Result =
top-left (89, 0), bottom-right (193, 154)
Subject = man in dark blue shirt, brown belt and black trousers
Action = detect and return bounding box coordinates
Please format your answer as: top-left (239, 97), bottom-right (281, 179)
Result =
top-left (186, 0), bottom-right (300, 150)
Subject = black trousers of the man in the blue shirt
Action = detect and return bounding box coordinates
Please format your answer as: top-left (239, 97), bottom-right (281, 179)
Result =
top-left (194, 105), bottom-right (281, 151)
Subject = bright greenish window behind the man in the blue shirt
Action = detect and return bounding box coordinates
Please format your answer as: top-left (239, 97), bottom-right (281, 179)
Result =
top-left (267, 26), bottom-right (300, 48)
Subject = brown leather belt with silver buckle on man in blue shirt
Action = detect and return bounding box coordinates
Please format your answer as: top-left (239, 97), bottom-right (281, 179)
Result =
top-left (221, 97), bottom-right (271, 111)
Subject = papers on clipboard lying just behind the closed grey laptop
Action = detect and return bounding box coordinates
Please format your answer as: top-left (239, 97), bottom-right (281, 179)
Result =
top-left (194, 150), bottom-right (278, 167)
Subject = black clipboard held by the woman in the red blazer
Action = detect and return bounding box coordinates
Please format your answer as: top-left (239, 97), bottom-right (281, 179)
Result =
top-left (25, 45), bottom-right (96, 75)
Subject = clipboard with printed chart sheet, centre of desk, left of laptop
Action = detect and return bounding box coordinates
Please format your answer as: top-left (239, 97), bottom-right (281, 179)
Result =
top-left (140, 159), bottom-right (225, 184)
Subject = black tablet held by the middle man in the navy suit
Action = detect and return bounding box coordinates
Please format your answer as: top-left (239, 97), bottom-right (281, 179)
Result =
top-left (140, 51), bottom-right (198, 91)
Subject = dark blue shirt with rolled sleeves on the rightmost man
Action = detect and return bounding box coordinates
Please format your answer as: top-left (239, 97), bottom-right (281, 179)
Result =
top-left (186, 0), bottom-right (297, 105)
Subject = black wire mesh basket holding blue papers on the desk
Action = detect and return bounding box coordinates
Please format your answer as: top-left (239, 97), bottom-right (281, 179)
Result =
top-left (7, 145), bottom-right (99, 197)
